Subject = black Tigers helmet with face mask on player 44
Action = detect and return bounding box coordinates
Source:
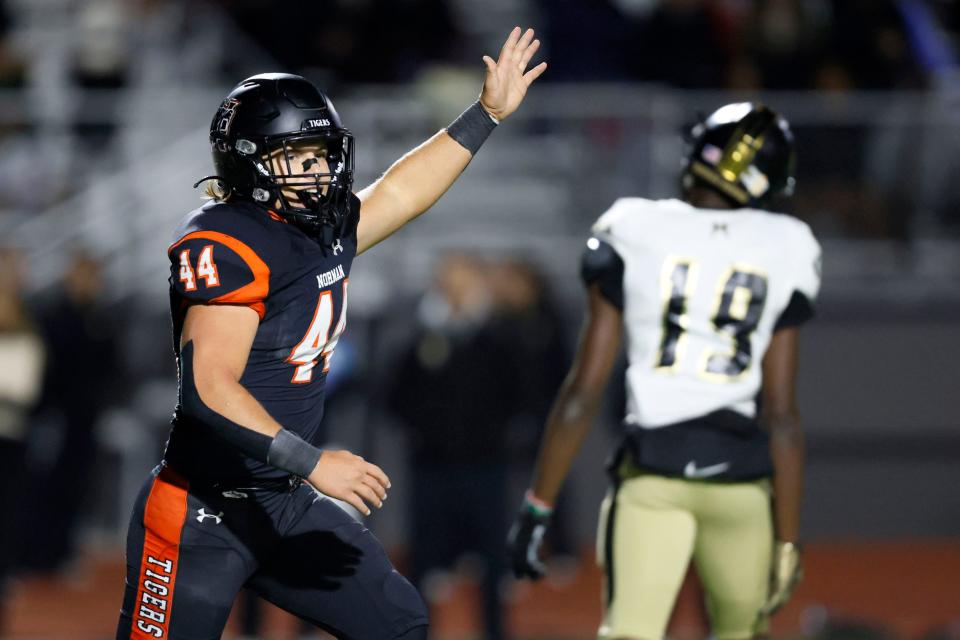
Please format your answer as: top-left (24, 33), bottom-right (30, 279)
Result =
top-left (204, 73), bottom-right (353, 233)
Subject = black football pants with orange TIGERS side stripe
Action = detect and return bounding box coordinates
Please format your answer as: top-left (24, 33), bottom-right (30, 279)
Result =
top-left (117, 468), bottom-right (427, 640)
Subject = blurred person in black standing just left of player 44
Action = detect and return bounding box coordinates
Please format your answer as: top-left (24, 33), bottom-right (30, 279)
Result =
top-left (21, 251), bottom-right (123, 571)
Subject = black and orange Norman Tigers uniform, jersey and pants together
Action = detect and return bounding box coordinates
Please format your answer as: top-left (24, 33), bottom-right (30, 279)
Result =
top-left (117, 197), bottom-right (427, 640)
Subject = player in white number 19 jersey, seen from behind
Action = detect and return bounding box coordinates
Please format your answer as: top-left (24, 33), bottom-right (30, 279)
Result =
top-left (508, 103), bottom-right (820, 640)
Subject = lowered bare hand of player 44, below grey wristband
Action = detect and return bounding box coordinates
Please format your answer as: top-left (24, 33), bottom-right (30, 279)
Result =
top-left (307, 449), bottom-right (390, 516)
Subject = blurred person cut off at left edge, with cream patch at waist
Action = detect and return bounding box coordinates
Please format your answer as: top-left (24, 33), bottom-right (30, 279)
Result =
top-left (0, 249), bottom-right (45, 633)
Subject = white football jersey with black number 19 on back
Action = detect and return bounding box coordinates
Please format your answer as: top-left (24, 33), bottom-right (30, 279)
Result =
top-left (593, 198), bottom-right (820, 428)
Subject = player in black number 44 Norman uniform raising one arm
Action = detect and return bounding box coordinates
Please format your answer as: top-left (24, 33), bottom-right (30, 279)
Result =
top-left (117, 28), bottom-right (546, 640)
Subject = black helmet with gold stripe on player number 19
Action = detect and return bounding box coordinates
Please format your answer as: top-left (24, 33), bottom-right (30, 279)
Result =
top-left (681, 102), bottom-right (796, 207)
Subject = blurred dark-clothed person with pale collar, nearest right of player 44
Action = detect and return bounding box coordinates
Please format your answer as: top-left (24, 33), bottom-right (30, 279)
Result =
top-left (389, 254), bottom-right (520, 640)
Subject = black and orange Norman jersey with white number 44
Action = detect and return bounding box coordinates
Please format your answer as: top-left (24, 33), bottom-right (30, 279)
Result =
top-left (164, 196), bottom-right (360, 486)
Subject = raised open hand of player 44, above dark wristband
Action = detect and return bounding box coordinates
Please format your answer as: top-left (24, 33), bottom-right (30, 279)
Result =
top-left (480, 27), bottom-right (547, 120)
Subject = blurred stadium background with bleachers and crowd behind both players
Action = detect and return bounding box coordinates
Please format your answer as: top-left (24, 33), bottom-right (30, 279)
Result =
top-left (0, 0), bottom-right (960, 640)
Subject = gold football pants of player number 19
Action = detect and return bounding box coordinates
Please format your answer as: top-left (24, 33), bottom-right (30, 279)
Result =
top-left (597, 466), bottom-right (773, 640)
